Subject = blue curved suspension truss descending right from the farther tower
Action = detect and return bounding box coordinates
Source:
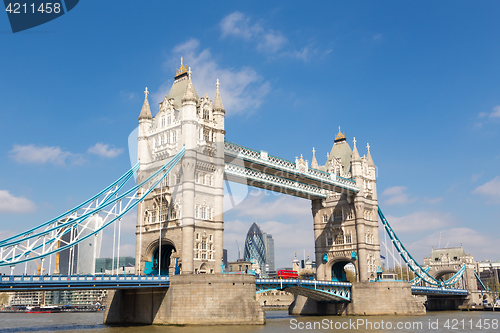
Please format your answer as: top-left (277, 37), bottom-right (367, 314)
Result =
top-left (378, 207), bottom-right (465, 287)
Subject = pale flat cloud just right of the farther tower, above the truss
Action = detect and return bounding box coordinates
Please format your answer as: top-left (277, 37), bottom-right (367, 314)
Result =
top-left (381, 212), bottom-right (453, 234)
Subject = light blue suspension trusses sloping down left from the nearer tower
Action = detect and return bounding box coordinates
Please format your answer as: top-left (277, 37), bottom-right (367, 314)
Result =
top-left (0, 147), bottom-right (185, 267)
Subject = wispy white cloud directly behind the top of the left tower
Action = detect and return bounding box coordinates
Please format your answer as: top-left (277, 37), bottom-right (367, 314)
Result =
top-left (157, 39), bottom-right (270, 116)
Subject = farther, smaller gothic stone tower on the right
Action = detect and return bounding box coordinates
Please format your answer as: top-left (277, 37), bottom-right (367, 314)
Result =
top-left (311, 128), bottom-right (380, 282)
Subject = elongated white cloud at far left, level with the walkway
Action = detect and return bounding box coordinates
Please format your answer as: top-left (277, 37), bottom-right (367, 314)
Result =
top-left (9, 144), bottom-right (85, 165)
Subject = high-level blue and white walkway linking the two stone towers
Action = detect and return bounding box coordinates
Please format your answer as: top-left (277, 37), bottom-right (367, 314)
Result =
top-left (224, 141), bottom-right (359, 199)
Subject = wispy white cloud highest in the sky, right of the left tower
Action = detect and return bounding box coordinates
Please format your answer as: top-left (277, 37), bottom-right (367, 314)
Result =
top-left (220, 11), bottom-right (320, 61)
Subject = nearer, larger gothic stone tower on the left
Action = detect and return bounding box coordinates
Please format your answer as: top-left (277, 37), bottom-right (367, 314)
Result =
top-left (136, 58), bottom-right (225, 275)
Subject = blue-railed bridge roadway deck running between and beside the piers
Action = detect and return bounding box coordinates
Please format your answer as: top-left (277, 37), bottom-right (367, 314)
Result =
top-left (0, 275), bottom-right (468, 302)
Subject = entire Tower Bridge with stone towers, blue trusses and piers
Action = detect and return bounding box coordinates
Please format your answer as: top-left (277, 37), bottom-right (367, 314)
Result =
top-left (0, 60), bottom-right (480, 324)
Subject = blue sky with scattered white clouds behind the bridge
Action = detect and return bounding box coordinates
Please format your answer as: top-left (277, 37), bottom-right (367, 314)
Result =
top-left (0, 0), bottom-right (500, 272)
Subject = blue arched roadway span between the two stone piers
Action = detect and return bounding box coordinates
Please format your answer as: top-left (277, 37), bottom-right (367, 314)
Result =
top-left (255, 279), bottom-right (352, 302)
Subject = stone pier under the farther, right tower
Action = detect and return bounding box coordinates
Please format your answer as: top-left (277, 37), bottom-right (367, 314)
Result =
top-left (288, 282), bottom-right (425, 316)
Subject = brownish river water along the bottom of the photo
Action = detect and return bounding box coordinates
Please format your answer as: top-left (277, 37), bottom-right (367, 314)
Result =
top-left (0, 311), bottom-right (500, 333)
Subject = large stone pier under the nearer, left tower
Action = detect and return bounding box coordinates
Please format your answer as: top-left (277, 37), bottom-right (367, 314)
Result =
top-left (104, 274), bottom-right (265, 325)
